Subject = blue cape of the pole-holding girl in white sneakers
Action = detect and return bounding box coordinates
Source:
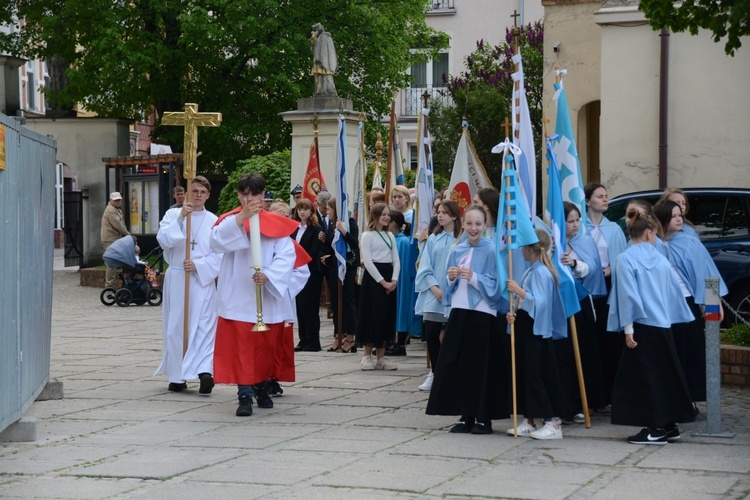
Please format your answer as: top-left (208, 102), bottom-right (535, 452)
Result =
top-left (518, 261), bottom-right (568, 339)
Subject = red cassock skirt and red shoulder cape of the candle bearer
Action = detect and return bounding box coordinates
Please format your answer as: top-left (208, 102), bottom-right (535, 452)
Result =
top-left (214, 208), bottom-right (311, 385)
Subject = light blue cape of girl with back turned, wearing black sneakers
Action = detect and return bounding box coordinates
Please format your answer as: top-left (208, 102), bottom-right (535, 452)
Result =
top-left (607, 242), bottom-right (694, 332)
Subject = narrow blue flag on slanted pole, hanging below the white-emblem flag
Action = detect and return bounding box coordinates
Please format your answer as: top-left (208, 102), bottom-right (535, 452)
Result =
top-left (545, 137), bottom-right (588, 318)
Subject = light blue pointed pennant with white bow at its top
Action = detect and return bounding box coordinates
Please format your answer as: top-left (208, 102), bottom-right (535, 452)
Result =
top-left (500, 150), bottom-right (539, 300)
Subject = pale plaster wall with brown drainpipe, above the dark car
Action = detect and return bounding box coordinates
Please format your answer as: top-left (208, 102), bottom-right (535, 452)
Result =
top-left (596, 6), bottom-right (750, 196)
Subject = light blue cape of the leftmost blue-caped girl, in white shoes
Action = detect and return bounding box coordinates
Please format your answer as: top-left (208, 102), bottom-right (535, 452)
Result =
top-left (414, 231), bottom-right (456, 318)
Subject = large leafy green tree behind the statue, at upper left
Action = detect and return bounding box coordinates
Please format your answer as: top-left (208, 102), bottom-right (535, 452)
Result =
top-left (0, 0), bottom-right (448, 172)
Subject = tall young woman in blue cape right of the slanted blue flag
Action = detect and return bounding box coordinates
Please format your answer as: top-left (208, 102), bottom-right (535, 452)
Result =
top-left (583, 182), bottom-right (627, 412)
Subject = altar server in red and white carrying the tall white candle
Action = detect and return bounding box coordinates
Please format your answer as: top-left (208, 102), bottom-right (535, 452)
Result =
top-left (211, 173), bottom-right (310, 416)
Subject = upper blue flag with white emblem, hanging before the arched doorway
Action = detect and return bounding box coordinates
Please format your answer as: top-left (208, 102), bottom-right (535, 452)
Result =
top-left (553, 70), bottom-right (586, 233)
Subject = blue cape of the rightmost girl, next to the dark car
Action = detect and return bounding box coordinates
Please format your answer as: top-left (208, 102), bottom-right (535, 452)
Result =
top-left (666, 231), bottom-right (729, 305)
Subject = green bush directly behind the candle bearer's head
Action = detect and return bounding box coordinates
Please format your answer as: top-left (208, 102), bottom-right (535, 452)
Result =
top-left (219, 149), bottom-right (292, 213)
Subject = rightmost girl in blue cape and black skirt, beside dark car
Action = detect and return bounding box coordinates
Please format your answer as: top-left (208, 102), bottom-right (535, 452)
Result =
top-left (654, 199), bottom-right (727, 404)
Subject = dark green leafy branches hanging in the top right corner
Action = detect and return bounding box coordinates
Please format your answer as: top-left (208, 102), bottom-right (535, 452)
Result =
top-left (638, 0), bottom-right (750, 56)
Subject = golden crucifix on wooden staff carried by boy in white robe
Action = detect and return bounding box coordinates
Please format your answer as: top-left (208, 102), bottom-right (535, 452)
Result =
top-left (161, 103), bottom-right (221, 358)
